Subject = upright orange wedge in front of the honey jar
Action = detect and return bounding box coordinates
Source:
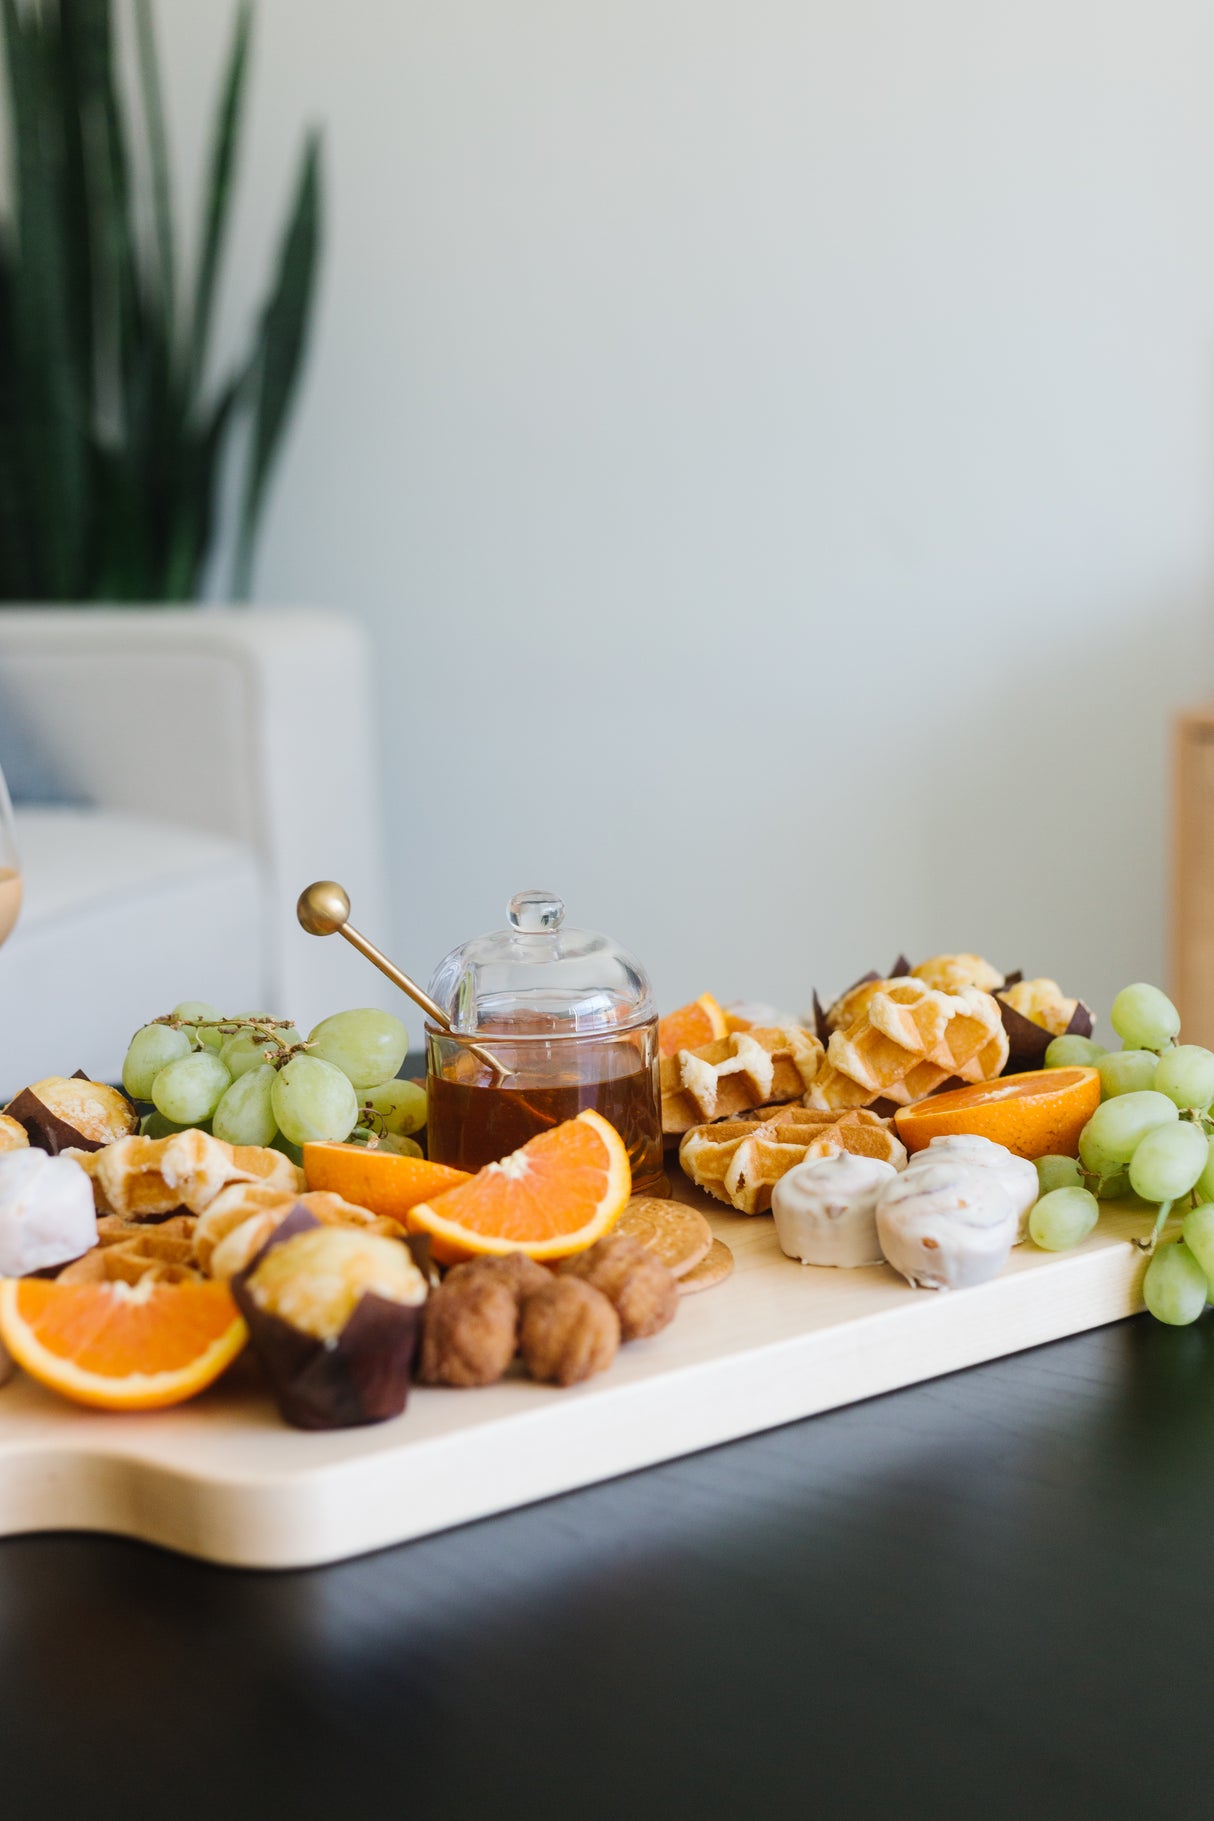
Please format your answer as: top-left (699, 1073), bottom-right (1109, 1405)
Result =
top-left (408, 1107), bottom-right (632, 1264)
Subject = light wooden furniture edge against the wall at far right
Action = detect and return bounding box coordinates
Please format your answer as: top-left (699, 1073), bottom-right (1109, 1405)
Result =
top-left (1172, 707), bottom-right (1214, 1047)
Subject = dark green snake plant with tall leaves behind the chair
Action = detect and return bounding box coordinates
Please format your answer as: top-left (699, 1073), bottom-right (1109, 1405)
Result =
top-left (0, 0), bottom-right (322, 603)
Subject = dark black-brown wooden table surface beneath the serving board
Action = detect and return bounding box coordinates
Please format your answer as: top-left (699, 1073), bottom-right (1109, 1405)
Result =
top-left (0, 1317), bottom-right (1214, 1821)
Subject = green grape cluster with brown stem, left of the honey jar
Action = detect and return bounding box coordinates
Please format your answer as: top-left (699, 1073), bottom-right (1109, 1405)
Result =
top-left (122, 1000), bottom-right (426, 1160)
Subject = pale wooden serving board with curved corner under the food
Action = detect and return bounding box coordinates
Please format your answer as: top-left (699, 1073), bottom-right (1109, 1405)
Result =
top-left (0, 1204), bottom-right (1145, 1568)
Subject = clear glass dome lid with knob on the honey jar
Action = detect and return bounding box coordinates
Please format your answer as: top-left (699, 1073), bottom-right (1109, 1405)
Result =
top-left (430, 890), bottom-right (655, 1038)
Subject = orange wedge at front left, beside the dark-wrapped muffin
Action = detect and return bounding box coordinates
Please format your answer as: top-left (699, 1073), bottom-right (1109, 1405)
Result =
top-left (0, 1277), bottom-right (248, 1409)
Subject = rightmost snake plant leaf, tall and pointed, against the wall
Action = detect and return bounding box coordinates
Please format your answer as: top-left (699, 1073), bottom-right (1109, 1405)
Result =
top-left (235, 133), bottom-right (320, 599)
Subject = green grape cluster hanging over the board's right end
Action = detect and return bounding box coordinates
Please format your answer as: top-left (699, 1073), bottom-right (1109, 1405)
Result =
top-left (1028, 982), bottom-right (1214, 1326)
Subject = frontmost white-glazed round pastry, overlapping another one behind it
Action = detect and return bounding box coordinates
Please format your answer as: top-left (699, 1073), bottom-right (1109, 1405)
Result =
top-left (877, 1158), bottom-right (1019, 1289)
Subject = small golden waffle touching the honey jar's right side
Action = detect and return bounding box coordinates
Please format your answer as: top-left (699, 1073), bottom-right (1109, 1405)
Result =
top-left (661, 1025), bottom-right (823, 1136)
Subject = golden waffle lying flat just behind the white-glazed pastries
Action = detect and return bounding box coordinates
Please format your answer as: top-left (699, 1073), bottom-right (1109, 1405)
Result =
top-left (679, 1107), bottom-right (906, 1215)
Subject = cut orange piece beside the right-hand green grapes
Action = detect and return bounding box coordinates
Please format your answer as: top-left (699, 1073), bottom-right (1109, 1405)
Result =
top-left (894, 1069), bottom-right (1099, 1158)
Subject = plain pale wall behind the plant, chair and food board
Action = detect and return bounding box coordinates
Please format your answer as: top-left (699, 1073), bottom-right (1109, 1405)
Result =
top-left (149, 0), bottom-right (1214, 1007)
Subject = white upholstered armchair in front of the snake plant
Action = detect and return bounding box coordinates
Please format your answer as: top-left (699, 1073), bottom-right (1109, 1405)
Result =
top-left (0, 608), bottom-right (389, 1094)
